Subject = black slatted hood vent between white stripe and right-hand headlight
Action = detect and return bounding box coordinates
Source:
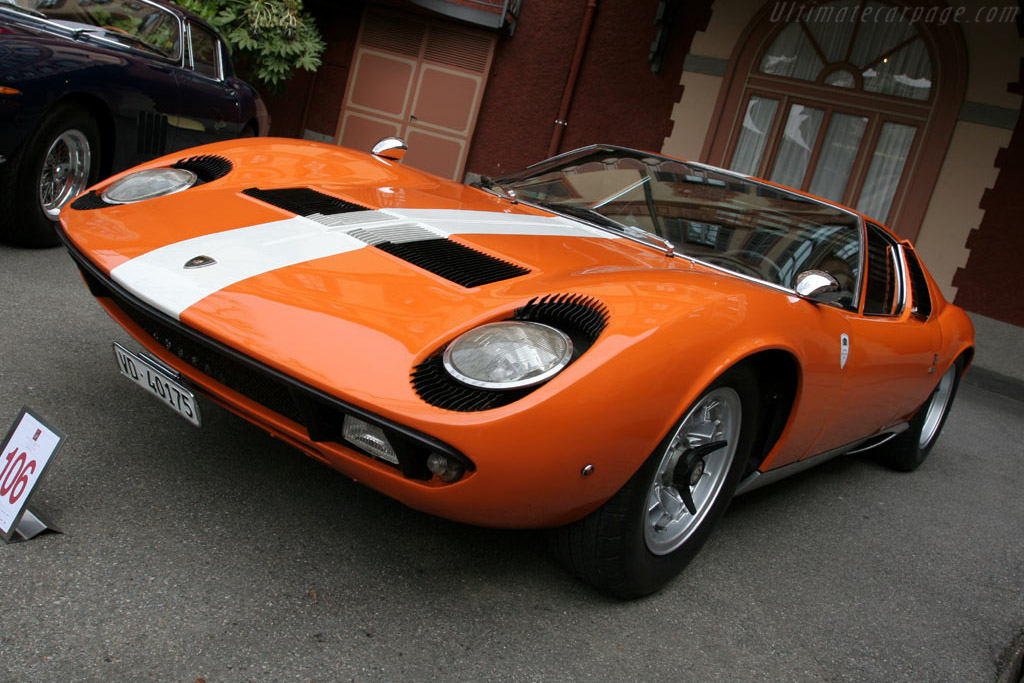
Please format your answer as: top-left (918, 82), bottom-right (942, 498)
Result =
top-left (376, 238), bottom-right (529, 288)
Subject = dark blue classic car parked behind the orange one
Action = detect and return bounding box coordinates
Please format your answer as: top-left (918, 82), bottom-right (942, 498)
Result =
top-left (0, 0), bottom-right (269, 247)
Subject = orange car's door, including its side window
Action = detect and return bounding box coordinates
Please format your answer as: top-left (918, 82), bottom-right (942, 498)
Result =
top-left (812, 221), bottom-right (942, 453)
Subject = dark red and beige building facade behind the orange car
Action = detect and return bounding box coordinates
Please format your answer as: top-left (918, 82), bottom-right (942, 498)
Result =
top-left (269, 0), bottom-right (1024, 362)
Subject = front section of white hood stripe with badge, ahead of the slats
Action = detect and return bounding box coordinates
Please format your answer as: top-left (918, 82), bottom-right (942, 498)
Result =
top-left (111, 216), bottom-right (367, 318)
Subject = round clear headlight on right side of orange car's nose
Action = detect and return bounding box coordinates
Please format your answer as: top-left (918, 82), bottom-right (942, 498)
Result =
top-left (443, 321), bottom-right (572, 389)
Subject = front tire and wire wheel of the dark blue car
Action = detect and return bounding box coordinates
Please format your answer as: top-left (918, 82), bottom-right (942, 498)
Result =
top-left (0, 104), bottom-right (100, 247)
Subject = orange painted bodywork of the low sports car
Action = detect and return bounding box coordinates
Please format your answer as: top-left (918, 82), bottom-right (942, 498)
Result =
top-left (61, 138), bottom-right (973, 527)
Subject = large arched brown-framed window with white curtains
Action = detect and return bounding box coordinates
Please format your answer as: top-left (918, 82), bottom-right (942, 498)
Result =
top-left (710, 0), bottom-right (964, 238)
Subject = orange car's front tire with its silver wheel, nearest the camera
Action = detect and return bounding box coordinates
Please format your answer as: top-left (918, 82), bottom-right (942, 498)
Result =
top-left (548, 369), bottom-right (759, 599)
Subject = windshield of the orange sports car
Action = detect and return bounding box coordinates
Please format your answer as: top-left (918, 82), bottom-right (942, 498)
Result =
top-left (495, 146), bottom-right (861, 306)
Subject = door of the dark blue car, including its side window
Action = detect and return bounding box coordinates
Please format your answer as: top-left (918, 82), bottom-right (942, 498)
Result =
top-left (172, 22), bottom-right (242, 148)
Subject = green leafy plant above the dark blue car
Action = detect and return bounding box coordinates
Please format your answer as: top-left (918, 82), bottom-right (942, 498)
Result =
top-left (177, 0), bottom-right (326, 91)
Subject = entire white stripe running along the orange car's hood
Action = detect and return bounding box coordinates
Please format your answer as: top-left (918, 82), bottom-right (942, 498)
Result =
top-left (111, 209), bottom-right (618, 318)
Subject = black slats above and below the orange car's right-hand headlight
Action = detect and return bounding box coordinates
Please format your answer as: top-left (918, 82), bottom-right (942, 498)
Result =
top-left (411, 294), bottom-right (608, 413)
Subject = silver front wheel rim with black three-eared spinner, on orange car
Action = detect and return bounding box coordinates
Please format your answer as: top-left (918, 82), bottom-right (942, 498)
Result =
top-left (644, 386), bottom-right (742, 555)
